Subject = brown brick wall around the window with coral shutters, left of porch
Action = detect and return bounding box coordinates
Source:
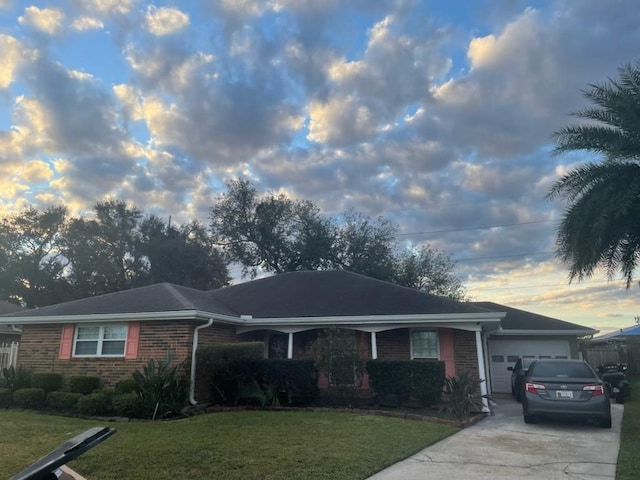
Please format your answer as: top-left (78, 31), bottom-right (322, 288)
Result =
top-left (18, 321), bottom-right (242, 387)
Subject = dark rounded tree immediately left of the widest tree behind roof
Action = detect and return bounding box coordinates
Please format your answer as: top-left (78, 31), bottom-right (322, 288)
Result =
top-left (137, 215), bottom-right (230, 290)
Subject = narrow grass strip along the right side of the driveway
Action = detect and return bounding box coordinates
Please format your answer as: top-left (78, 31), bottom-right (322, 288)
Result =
top-left (616, 380), bottom-right (640, 480)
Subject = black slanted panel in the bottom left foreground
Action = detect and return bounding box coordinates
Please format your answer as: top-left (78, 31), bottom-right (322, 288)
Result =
top-left (9, 427), bottom-right (116, 480)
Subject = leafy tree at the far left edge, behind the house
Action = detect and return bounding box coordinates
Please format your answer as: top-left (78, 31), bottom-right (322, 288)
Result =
top-left (0, 206), bottom-right (70, 307)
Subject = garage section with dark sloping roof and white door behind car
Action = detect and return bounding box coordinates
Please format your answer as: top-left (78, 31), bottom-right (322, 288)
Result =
top-left (473, 302), bottom-right (598, 393)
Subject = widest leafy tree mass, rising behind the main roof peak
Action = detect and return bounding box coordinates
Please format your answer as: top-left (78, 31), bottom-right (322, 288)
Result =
top-left (210, 180), bottom-right (464, 299)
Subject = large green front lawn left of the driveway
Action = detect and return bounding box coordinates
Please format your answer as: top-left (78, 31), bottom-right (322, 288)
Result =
top-left (0, 410), bottom-right (457, 480)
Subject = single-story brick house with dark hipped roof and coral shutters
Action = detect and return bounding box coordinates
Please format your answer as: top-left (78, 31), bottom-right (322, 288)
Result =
top-left (0, 271), bottom-right (596, 408)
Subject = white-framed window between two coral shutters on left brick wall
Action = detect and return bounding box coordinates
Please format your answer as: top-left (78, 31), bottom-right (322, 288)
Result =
top-left (73, 324), bottom-right (127, 357)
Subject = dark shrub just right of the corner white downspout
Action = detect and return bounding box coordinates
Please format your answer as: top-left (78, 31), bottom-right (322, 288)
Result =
top-left (196, 342), bottom-right (264, 405)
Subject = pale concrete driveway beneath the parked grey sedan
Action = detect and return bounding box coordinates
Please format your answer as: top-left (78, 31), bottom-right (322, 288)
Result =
top-left (370, 396), bottom-right (623, 480)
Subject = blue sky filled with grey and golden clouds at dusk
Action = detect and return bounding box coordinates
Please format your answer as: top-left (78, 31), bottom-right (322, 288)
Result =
top-left (0, 0), bottom-right (640, 332)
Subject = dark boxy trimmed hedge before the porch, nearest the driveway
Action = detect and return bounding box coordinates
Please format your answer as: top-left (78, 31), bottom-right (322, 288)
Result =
top-left (367, 359), bottom-right (445, 405)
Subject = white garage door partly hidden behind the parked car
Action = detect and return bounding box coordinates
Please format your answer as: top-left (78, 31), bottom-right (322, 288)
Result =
top-left (489, 340), bottom-right (571, 393)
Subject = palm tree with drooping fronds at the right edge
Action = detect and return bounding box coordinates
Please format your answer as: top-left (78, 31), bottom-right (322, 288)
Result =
top-left (548, 61), bottom-right (640, 288)
